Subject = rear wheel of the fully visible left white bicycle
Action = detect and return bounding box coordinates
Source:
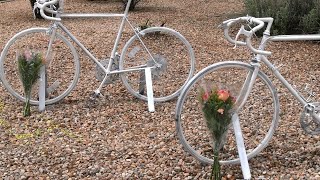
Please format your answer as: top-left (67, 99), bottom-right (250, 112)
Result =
top-left (119, 27), bottom-right (195, 102)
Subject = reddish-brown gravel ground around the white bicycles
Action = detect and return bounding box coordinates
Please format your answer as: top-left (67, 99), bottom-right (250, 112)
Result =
top-left (0, 0), bottom-right (320, 179)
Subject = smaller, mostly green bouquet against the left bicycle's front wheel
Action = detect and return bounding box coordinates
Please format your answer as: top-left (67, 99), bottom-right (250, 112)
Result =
top-left (17, 50), bottom-right (44, 117)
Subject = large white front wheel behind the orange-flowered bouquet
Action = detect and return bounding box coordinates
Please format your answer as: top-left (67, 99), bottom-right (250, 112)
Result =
top-left (176, 61), bottom-right (279, 164)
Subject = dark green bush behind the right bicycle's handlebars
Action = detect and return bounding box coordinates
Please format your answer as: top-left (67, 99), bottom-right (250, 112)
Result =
top-left (245, 0), bottom-right (320, 34)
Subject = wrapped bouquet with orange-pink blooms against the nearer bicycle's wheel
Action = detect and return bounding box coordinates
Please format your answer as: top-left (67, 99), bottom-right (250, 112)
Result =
top-left (199, 83), bottom-right (235, 180)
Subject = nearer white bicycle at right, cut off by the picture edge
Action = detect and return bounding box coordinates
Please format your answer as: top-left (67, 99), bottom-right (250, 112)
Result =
top-left (175, 17), bottom-right (320, 164)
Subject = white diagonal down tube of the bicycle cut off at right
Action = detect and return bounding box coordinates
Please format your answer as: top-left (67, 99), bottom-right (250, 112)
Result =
top-left (262, 56), bottom-right (307, 106)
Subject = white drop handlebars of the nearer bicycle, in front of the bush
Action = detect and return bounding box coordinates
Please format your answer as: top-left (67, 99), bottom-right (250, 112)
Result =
top-left (222, 16), bottom-right (271, 55)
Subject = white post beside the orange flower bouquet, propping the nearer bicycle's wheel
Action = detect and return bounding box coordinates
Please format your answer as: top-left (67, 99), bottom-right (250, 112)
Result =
top-left (232, 113), bottom-right (251, 179)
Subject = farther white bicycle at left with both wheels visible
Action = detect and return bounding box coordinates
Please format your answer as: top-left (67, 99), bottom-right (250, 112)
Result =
top-left (0, 0), bottom-right (195, 105)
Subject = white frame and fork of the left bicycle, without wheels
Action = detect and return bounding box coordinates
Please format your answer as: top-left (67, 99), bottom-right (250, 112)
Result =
top-left (47, 0), bottom-right (157, 94)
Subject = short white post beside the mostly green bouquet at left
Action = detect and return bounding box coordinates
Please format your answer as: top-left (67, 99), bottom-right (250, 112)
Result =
top-left (39, 65), bottom-right (46, 112)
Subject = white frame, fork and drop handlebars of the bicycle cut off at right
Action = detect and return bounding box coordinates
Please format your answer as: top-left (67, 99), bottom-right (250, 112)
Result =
top-left (220, 16), bottom-right (320, 134)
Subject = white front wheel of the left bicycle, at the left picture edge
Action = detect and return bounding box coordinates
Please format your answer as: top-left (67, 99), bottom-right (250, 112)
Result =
top-left (0, 28), bottom-right (80, 105)
